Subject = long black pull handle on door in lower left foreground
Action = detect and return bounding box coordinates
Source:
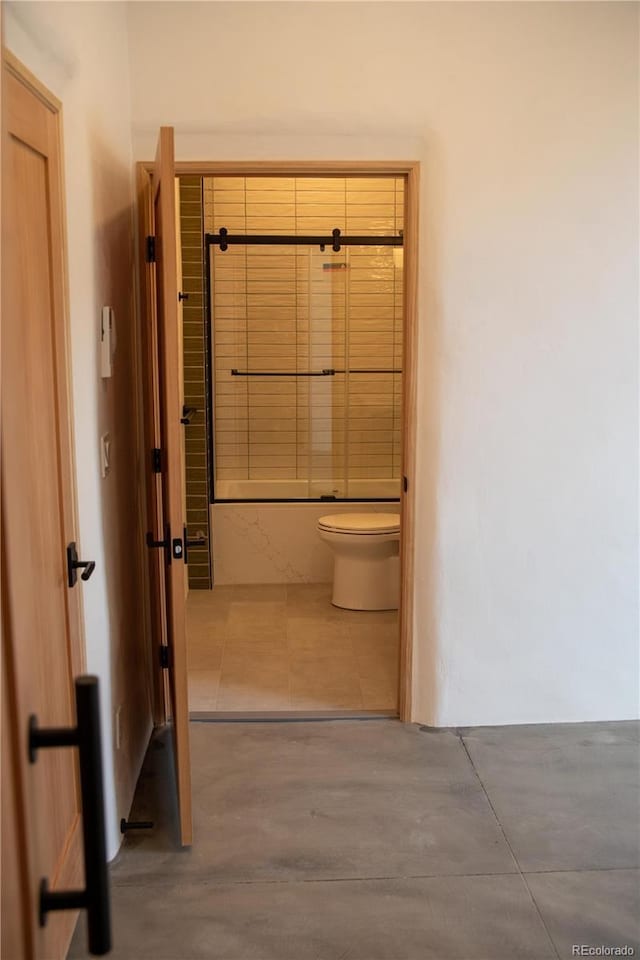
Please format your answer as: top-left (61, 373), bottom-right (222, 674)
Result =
top-left (29, 676), bottom-right (111, 956)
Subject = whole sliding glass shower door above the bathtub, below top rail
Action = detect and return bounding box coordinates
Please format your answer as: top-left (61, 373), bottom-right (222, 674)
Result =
top-left (207, 175), bottom-right (403, 500)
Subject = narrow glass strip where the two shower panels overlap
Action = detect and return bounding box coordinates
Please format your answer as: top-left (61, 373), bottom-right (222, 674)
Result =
top-left (306, 248), bottom-right (348, 499)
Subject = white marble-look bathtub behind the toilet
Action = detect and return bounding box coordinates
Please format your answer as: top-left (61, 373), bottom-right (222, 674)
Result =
top-left (211, 480), bottom-right (400, 589)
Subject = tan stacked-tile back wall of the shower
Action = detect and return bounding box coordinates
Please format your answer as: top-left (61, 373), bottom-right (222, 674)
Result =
top-left (204, 177), bottom-right (404, 496)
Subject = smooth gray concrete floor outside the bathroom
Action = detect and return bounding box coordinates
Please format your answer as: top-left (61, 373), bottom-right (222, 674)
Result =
top-left (70, 720), bottom-right (640, 960)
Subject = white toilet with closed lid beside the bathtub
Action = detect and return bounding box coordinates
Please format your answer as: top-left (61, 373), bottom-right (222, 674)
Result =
top-left (318, 513), bottom-right (400, 610)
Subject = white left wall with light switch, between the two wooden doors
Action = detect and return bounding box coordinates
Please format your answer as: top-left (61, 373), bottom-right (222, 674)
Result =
top-left (3, 2), bottom-right (150, 856)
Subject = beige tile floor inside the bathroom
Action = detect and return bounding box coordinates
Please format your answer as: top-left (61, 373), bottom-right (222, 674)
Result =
top-left (182, 584), bottom-right (398, 714)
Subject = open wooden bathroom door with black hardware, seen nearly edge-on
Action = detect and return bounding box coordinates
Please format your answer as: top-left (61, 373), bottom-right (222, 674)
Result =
top-left (145, 127), bottom-right (193, 846)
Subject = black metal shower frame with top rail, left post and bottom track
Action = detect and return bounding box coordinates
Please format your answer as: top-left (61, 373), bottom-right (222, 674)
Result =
top-left (204, 227), bottom-right (404, 503)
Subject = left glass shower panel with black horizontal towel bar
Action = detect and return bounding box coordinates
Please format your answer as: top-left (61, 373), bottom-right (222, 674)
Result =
top-left (211, 244), bottom-right (309, 500)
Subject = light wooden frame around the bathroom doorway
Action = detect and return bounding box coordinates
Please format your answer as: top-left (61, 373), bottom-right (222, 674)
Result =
top-left (137, 160), bottom-right (420, 723)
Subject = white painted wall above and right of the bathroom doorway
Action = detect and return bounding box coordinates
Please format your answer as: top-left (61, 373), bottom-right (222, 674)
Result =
top-left (129, 2), bottom-right (638, 725)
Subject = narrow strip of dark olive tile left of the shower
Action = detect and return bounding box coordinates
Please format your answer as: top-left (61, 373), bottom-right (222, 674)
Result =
top-left (180, 177), bottom-right (211, 590)
